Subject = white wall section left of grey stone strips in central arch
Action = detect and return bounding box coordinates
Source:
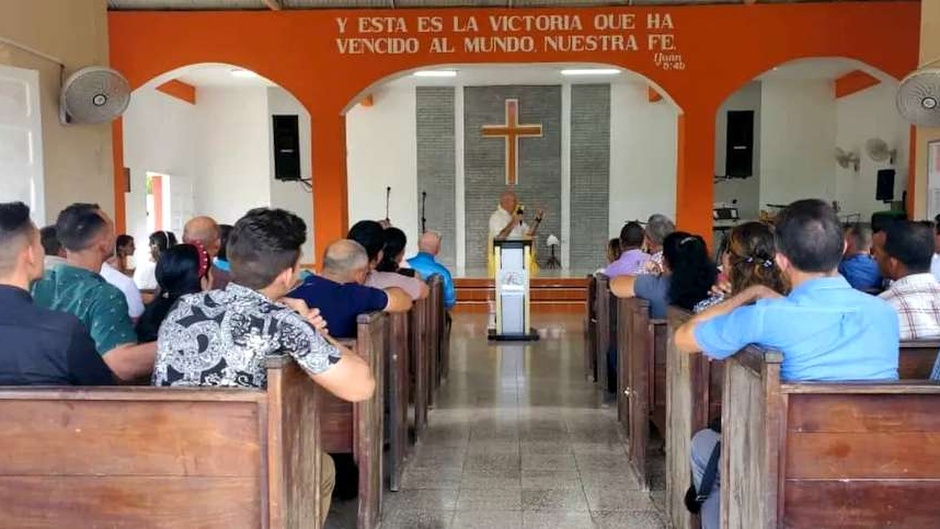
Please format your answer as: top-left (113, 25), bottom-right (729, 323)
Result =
top-left (346, 82), bottom-right (419, 255)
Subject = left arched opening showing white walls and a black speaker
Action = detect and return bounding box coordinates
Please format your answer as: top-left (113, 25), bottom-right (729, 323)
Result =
top-left (123, 63), bottom-right (313, 263)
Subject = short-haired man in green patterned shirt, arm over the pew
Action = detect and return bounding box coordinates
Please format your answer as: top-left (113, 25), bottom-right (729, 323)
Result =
top-left (32, 203), bottom-right (156, 381)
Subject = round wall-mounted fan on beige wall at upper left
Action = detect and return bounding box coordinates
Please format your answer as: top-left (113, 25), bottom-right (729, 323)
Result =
top-left (59, 66), bottom-right (131, 124)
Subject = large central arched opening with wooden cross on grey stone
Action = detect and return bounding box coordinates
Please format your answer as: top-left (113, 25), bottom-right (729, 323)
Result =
top-left (346, 64), bottom-right (680, 277)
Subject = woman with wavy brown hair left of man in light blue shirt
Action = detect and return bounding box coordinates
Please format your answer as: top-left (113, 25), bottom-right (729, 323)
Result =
top-left (693, 222), bottom-right (789, 313)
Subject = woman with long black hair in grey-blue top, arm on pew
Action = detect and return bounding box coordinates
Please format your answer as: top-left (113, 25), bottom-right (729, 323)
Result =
top-left (610, 231), bottom-right (718, 319)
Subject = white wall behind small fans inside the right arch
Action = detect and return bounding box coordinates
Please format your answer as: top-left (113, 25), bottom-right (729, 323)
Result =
top-left (833, 83), bottom-right (910, 222)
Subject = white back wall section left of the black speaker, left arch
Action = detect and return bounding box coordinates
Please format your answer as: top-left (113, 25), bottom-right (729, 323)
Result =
top-left (193, 87), bottom-right (271, 224)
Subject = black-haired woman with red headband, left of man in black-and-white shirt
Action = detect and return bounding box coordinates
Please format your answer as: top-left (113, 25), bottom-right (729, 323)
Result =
top-left (136, 244), bottom-right (212, 342)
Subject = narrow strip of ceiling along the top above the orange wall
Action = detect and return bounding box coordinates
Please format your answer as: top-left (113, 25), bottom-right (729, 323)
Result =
top-left (108, 0), bottom-right (901, 11)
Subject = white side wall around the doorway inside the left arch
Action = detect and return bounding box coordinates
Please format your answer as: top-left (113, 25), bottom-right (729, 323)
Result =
top-left (124, 88), bottom-right (200, 266)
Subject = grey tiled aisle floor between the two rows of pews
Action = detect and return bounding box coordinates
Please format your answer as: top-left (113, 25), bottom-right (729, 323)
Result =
top-left (327, 315), bottom-right (665, 529)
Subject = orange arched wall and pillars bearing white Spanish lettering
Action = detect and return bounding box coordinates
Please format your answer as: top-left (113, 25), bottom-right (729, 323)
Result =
top-left (109, 1), bottom-right (920, 248)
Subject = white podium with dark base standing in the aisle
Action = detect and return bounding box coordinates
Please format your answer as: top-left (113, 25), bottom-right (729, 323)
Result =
top-left (489, 239), bottom-right (539, 340)
